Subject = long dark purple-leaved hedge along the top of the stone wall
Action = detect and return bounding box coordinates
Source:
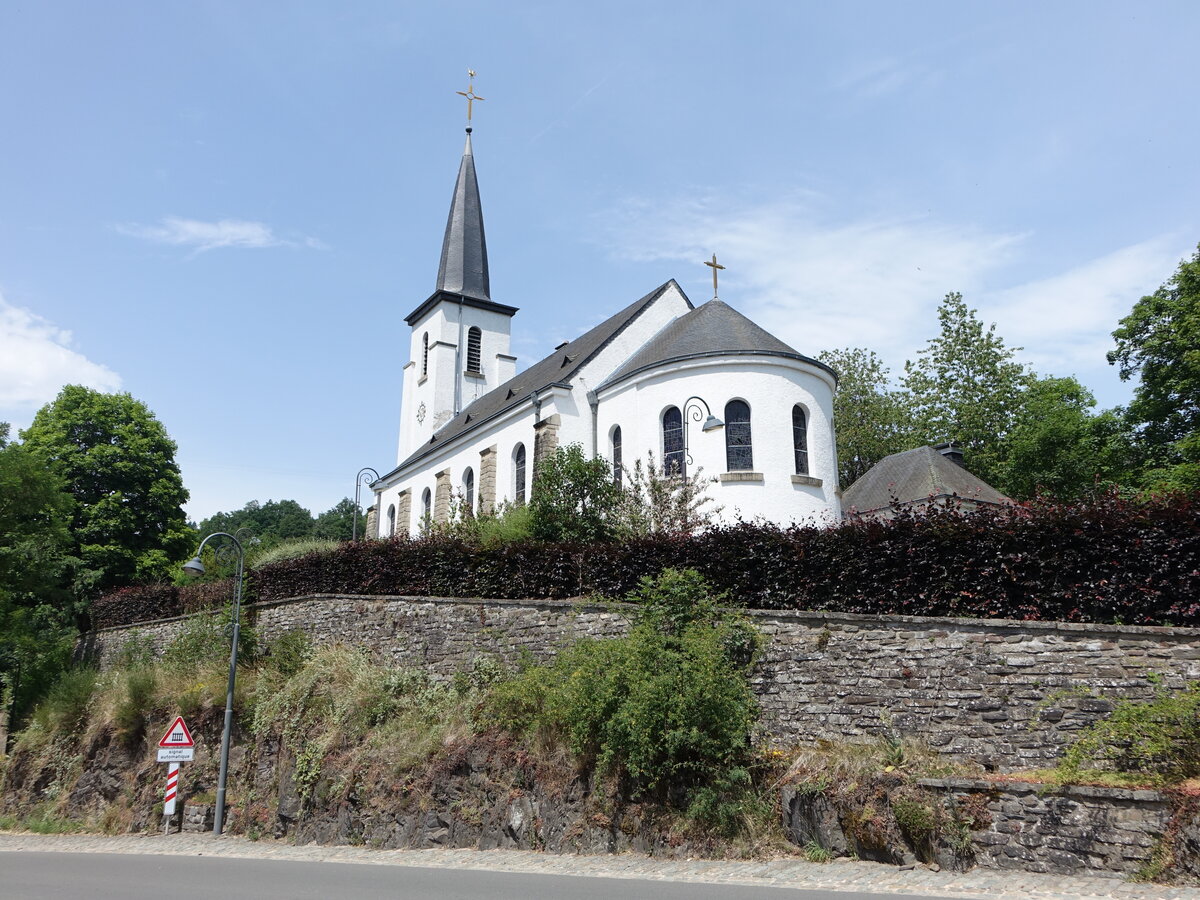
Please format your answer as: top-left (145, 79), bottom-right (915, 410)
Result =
top-left (91, 494), bottom-right (1200, 625)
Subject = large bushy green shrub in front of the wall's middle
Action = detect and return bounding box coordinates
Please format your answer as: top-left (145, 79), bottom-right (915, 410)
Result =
top-left (485, 571), bottom-right (757, 815)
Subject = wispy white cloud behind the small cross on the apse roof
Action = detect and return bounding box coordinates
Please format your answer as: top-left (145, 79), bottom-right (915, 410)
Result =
top-left (600, 194), bottom-right (1020, 368)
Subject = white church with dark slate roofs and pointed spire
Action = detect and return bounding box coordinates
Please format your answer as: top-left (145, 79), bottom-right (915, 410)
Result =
top-left (372, 127), bottom-right (841, 538)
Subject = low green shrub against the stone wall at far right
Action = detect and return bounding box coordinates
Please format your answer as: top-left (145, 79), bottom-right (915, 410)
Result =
top-left (1058, 682), bottom-right (1200, 781)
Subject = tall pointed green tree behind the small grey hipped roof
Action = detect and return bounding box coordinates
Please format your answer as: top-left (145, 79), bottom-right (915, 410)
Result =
top-left (904, 293), bottom-right (1031, 481)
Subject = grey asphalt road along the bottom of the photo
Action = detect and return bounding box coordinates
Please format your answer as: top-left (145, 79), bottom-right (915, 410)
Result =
top-left (0, 851), bottom-right (955, 900)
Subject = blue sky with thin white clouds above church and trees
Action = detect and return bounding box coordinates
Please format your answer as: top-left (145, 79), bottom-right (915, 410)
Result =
top-left (0, 0), bottom-right (1200, 521)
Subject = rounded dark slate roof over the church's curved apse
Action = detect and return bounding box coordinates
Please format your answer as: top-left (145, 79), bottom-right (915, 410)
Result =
top-left (601, 298), bottom-right (836, 386)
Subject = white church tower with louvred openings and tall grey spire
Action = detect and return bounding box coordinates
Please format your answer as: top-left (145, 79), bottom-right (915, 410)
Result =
top-left (396, 82), bottom-right (517, 464)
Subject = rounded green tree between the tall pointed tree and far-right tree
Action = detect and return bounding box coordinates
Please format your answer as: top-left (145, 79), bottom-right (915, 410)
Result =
top-left (995, 378), bottom-right (1132, 499)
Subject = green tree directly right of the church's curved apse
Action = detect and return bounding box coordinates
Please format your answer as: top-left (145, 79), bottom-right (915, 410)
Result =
top-left (817, 347), bottom-right (913, 487)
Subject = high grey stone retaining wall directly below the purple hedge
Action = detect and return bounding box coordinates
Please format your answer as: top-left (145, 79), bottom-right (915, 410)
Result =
top-left (80, 594), bottom-right (1200, 772)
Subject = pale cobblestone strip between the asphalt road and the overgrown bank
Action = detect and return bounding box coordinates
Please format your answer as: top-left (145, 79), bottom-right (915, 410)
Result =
top-left (0, 833), bottom-right (1200, 900)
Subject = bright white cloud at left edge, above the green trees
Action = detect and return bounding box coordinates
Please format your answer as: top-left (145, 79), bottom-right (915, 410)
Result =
top-left (0, 296), bottom-right (121, 412)
